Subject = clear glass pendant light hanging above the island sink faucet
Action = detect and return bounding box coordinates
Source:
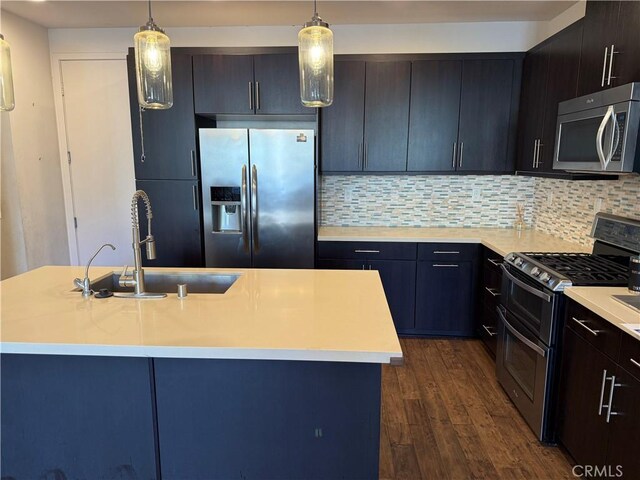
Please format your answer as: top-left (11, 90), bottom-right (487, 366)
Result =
top-left (133, 0), bottom-right (173, 110)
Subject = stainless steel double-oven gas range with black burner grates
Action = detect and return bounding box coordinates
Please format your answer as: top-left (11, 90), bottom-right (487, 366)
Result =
top-left (496, 213), bottom-right (640, 443)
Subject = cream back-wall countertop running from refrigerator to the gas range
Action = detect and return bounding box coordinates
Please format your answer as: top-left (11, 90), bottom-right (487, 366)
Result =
top-left (318, 227), bottom-right (591, 256)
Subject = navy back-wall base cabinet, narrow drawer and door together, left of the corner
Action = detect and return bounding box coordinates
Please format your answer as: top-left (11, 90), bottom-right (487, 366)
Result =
top-left (413, 243), bottom-right (479, 337)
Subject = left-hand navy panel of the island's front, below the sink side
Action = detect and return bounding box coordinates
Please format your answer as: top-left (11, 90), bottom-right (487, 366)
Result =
top-left (0, 354), bottom-right (160, 480)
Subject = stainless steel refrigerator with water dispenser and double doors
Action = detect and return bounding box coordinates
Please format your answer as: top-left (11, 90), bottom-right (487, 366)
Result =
top-left (199, 128), bottom-right (315, 268)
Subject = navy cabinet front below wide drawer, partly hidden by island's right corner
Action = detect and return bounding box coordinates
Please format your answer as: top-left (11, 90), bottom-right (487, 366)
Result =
top-left (317, 258), bottom-right (416, 333)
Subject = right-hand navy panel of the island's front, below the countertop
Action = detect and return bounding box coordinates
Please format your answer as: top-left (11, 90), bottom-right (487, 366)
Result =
top-left (155, 358), bottom-right (381, 480)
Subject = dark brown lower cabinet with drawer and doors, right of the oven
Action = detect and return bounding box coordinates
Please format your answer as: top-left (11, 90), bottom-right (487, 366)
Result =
top-left (559, 300), bottom-right (640, 479)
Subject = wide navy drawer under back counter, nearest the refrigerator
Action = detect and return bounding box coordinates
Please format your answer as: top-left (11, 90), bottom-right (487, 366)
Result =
top-left (318, 242), bottom-right (416, 260)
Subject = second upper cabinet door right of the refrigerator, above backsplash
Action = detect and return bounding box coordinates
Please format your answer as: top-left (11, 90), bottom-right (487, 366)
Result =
top-left (363, 62), bottom-right (411, 172)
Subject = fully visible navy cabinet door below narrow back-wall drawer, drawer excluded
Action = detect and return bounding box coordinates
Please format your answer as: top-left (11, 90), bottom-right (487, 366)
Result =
top-left (415, 261), bottom-right (474, 336)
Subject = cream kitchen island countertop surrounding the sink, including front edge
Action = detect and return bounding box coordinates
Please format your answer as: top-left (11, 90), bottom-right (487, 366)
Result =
top-left (0, 266), bottom-right (402, 363)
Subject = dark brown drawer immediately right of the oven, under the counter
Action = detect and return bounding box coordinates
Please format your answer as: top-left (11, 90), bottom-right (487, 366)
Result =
top-left (566, 300), bottom-right (622, 359)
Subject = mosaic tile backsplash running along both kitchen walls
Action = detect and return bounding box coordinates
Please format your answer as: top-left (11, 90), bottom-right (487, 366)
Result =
top-left (320, 175), bottom-right (640, 244)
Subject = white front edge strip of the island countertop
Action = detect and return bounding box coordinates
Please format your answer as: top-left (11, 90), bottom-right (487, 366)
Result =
top-left (0, 342), bottom-right (403, 365)
